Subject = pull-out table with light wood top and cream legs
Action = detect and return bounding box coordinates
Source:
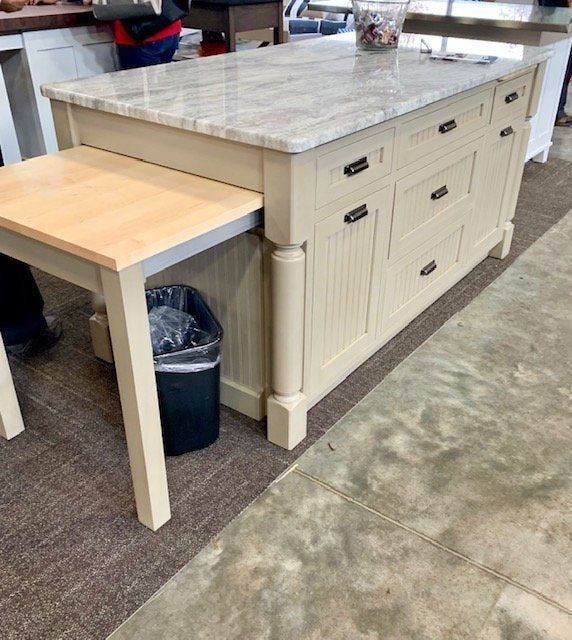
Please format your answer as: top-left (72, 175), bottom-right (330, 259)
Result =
top-left (0, 146), bottom-right (263, 531)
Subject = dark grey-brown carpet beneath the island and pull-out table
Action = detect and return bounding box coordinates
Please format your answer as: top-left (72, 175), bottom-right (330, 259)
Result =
top-left (0, 159), bottom-right (572, 640)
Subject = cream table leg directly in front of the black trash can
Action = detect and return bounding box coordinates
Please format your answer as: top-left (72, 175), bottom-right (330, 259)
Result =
top-left (101, 264), bottom-right (171, 531)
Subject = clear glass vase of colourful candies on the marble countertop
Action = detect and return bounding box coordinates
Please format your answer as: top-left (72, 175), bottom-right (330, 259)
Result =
top-left (352, 0), bottom-right (409, 51)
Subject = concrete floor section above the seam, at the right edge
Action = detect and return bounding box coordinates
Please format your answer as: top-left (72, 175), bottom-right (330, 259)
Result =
top-left (299, 213), bottom-right (572, 608)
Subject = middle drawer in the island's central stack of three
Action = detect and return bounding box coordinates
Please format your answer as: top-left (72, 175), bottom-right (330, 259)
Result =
top-left (389, 138), bottom-right (483, 259)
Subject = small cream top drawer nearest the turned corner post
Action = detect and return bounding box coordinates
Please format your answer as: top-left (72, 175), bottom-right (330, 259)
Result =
top-left (316, 129), bottom-right (395, 208)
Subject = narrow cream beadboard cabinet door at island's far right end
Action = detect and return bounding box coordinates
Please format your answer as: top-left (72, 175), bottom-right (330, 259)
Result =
top-left (472, 119), bottom-right (523, 256)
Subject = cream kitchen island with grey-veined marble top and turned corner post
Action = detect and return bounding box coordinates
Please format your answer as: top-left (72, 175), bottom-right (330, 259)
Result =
top-left (40, 34), bottom-right (549, 456)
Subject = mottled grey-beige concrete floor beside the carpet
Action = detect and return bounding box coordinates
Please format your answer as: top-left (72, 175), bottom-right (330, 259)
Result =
top-left (111, 212), bottom-right (572, 640)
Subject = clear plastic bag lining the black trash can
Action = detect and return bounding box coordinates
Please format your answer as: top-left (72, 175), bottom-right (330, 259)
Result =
top-left (145, 285), bottom-right (223, 373)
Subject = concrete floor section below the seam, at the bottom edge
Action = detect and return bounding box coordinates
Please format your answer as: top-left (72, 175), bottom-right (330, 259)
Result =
top-left (110, 473), bottom-right (566, 640)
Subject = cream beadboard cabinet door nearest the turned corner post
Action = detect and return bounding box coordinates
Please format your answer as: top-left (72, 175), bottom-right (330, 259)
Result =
top-left (311, 187), bottom-right (391, 393)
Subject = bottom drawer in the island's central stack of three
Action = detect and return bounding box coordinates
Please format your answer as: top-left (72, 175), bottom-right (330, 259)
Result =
top-left (381, 214), bottom-right (469, 333)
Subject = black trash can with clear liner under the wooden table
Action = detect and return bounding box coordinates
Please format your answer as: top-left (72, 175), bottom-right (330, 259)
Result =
top-left (145, 285), bottom-right (223, 456)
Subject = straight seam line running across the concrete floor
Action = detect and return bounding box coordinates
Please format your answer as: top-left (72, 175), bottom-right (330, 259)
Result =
top-left (293, 467), bottom-right (572, 615)
